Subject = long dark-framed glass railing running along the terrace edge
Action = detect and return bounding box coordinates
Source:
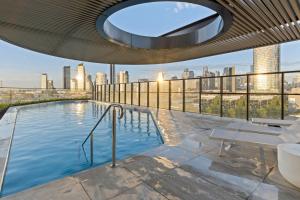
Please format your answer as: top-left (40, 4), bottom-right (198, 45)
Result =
top-left (95, 71), bottom-right (300, 120)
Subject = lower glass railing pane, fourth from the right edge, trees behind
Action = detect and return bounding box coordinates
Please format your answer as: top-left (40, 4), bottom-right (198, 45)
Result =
top-left (201, 94), bottom-right (221, 115)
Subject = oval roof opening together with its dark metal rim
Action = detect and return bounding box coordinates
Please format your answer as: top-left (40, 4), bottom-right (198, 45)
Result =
top-left (96, 0), bottom-right (232, 49)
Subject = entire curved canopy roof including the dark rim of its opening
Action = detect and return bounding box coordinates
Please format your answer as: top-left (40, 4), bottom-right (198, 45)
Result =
top-left (0, 0), bottom-right (300, 64)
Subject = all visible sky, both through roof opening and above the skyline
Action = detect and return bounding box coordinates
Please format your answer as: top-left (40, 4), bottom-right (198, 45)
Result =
top-left (0, 2), bottom-right (300, 88)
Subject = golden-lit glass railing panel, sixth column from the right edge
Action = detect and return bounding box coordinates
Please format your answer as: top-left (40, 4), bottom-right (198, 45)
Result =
top-left (171, 80), bottom-right (183, 110)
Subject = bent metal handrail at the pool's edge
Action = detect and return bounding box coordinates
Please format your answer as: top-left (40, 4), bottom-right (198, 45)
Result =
top-left (81, 104), bottom-right (124, 167)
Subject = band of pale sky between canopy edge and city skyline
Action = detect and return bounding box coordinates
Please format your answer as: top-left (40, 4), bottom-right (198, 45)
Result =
top-left (0, 41), bottom-right (300, 88)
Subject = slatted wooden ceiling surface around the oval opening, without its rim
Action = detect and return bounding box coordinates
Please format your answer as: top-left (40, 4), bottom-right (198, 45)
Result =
top-left (0, 0), bottom-right (300, 64)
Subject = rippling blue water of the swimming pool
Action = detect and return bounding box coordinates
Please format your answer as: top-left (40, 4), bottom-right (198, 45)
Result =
top-left (2, 101), bottom-right (162, 195)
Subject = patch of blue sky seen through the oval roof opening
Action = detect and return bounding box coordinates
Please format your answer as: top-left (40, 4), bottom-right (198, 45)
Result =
top-left (107, 1), bottom-right (216, 37)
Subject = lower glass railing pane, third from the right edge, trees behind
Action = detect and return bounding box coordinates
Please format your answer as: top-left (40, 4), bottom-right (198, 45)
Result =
top-left (223, 94), bottom-right (247, 119)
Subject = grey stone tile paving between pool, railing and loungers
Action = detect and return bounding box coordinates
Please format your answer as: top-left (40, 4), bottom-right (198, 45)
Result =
top-left (3, 110), bottom-right (300, 200)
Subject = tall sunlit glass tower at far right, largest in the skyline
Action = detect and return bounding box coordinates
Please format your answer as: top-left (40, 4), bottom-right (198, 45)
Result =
top-left (253, 44), bottom-right (280, 90)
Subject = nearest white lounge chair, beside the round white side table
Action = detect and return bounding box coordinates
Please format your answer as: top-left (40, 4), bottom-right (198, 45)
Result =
top-left (210, 129), bottom-right (300, 155)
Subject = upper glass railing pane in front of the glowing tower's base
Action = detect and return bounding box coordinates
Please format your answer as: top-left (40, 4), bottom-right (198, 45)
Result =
top-left (249, 74), bottom-right (281, 93)
